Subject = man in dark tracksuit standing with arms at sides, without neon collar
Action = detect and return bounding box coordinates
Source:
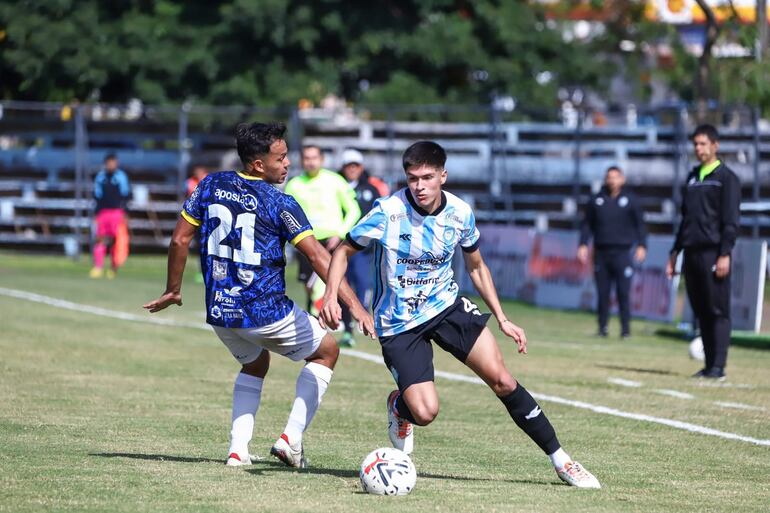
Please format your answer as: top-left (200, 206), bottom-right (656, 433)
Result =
top-left (577, 166), bottom-right (647, 338)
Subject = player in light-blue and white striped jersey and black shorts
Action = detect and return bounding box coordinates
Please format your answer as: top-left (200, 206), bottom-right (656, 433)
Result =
top-left (321, 141), bottom-right (600, 488)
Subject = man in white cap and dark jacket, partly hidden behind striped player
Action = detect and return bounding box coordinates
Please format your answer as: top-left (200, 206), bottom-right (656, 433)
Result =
top-left (341, 149), bottom-right (388, 308)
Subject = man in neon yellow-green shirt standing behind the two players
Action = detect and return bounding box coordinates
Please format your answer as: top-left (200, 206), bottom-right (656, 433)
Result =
top-left (285, 144), bottom-right (361, 347)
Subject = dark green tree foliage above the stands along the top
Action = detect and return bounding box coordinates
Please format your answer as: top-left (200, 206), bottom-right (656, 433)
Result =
top-left (0, 0), bottom-right (761, 109)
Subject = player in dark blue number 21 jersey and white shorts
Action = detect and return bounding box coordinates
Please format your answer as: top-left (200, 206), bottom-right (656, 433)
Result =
top-left (144, 123), bottom-right (374, 468)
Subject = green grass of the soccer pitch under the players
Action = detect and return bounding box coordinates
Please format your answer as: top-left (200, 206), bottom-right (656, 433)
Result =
top-left (0, 253), bottom-right (770, 513)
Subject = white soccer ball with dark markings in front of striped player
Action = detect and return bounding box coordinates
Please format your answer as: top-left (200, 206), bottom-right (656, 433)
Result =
top-left (359, 447), bottom-right (417, 495)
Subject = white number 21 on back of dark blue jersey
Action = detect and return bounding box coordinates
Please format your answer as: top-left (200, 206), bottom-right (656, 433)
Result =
top-left (207, 203), bottom-right (262, 265)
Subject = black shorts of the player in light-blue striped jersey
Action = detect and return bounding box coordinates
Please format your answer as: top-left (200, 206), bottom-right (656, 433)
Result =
top-left (380, 296), bottom-right (491, 392)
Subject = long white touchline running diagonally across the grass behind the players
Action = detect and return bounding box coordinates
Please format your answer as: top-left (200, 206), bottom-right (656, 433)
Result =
top-left (0, 287), bottom-right (770, 447)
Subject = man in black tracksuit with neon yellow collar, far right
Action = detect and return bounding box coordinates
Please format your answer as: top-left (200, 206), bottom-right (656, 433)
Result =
top-left (666, 125), bottom-right (741, 379)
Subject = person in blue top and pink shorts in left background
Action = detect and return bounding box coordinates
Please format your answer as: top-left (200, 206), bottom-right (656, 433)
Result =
top-left (89, 153), bottom-right (131, 279)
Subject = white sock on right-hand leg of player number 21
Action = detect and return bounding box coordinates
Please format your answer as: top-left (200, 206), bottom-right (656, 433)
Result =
top-left (283, 362), bottom-right (333, 444)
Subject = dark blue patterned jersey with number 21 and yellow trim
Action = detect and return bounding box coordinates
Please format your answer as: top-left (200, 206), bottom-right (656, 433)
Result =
top-left (182, 171), bottom-right (313, 328)
